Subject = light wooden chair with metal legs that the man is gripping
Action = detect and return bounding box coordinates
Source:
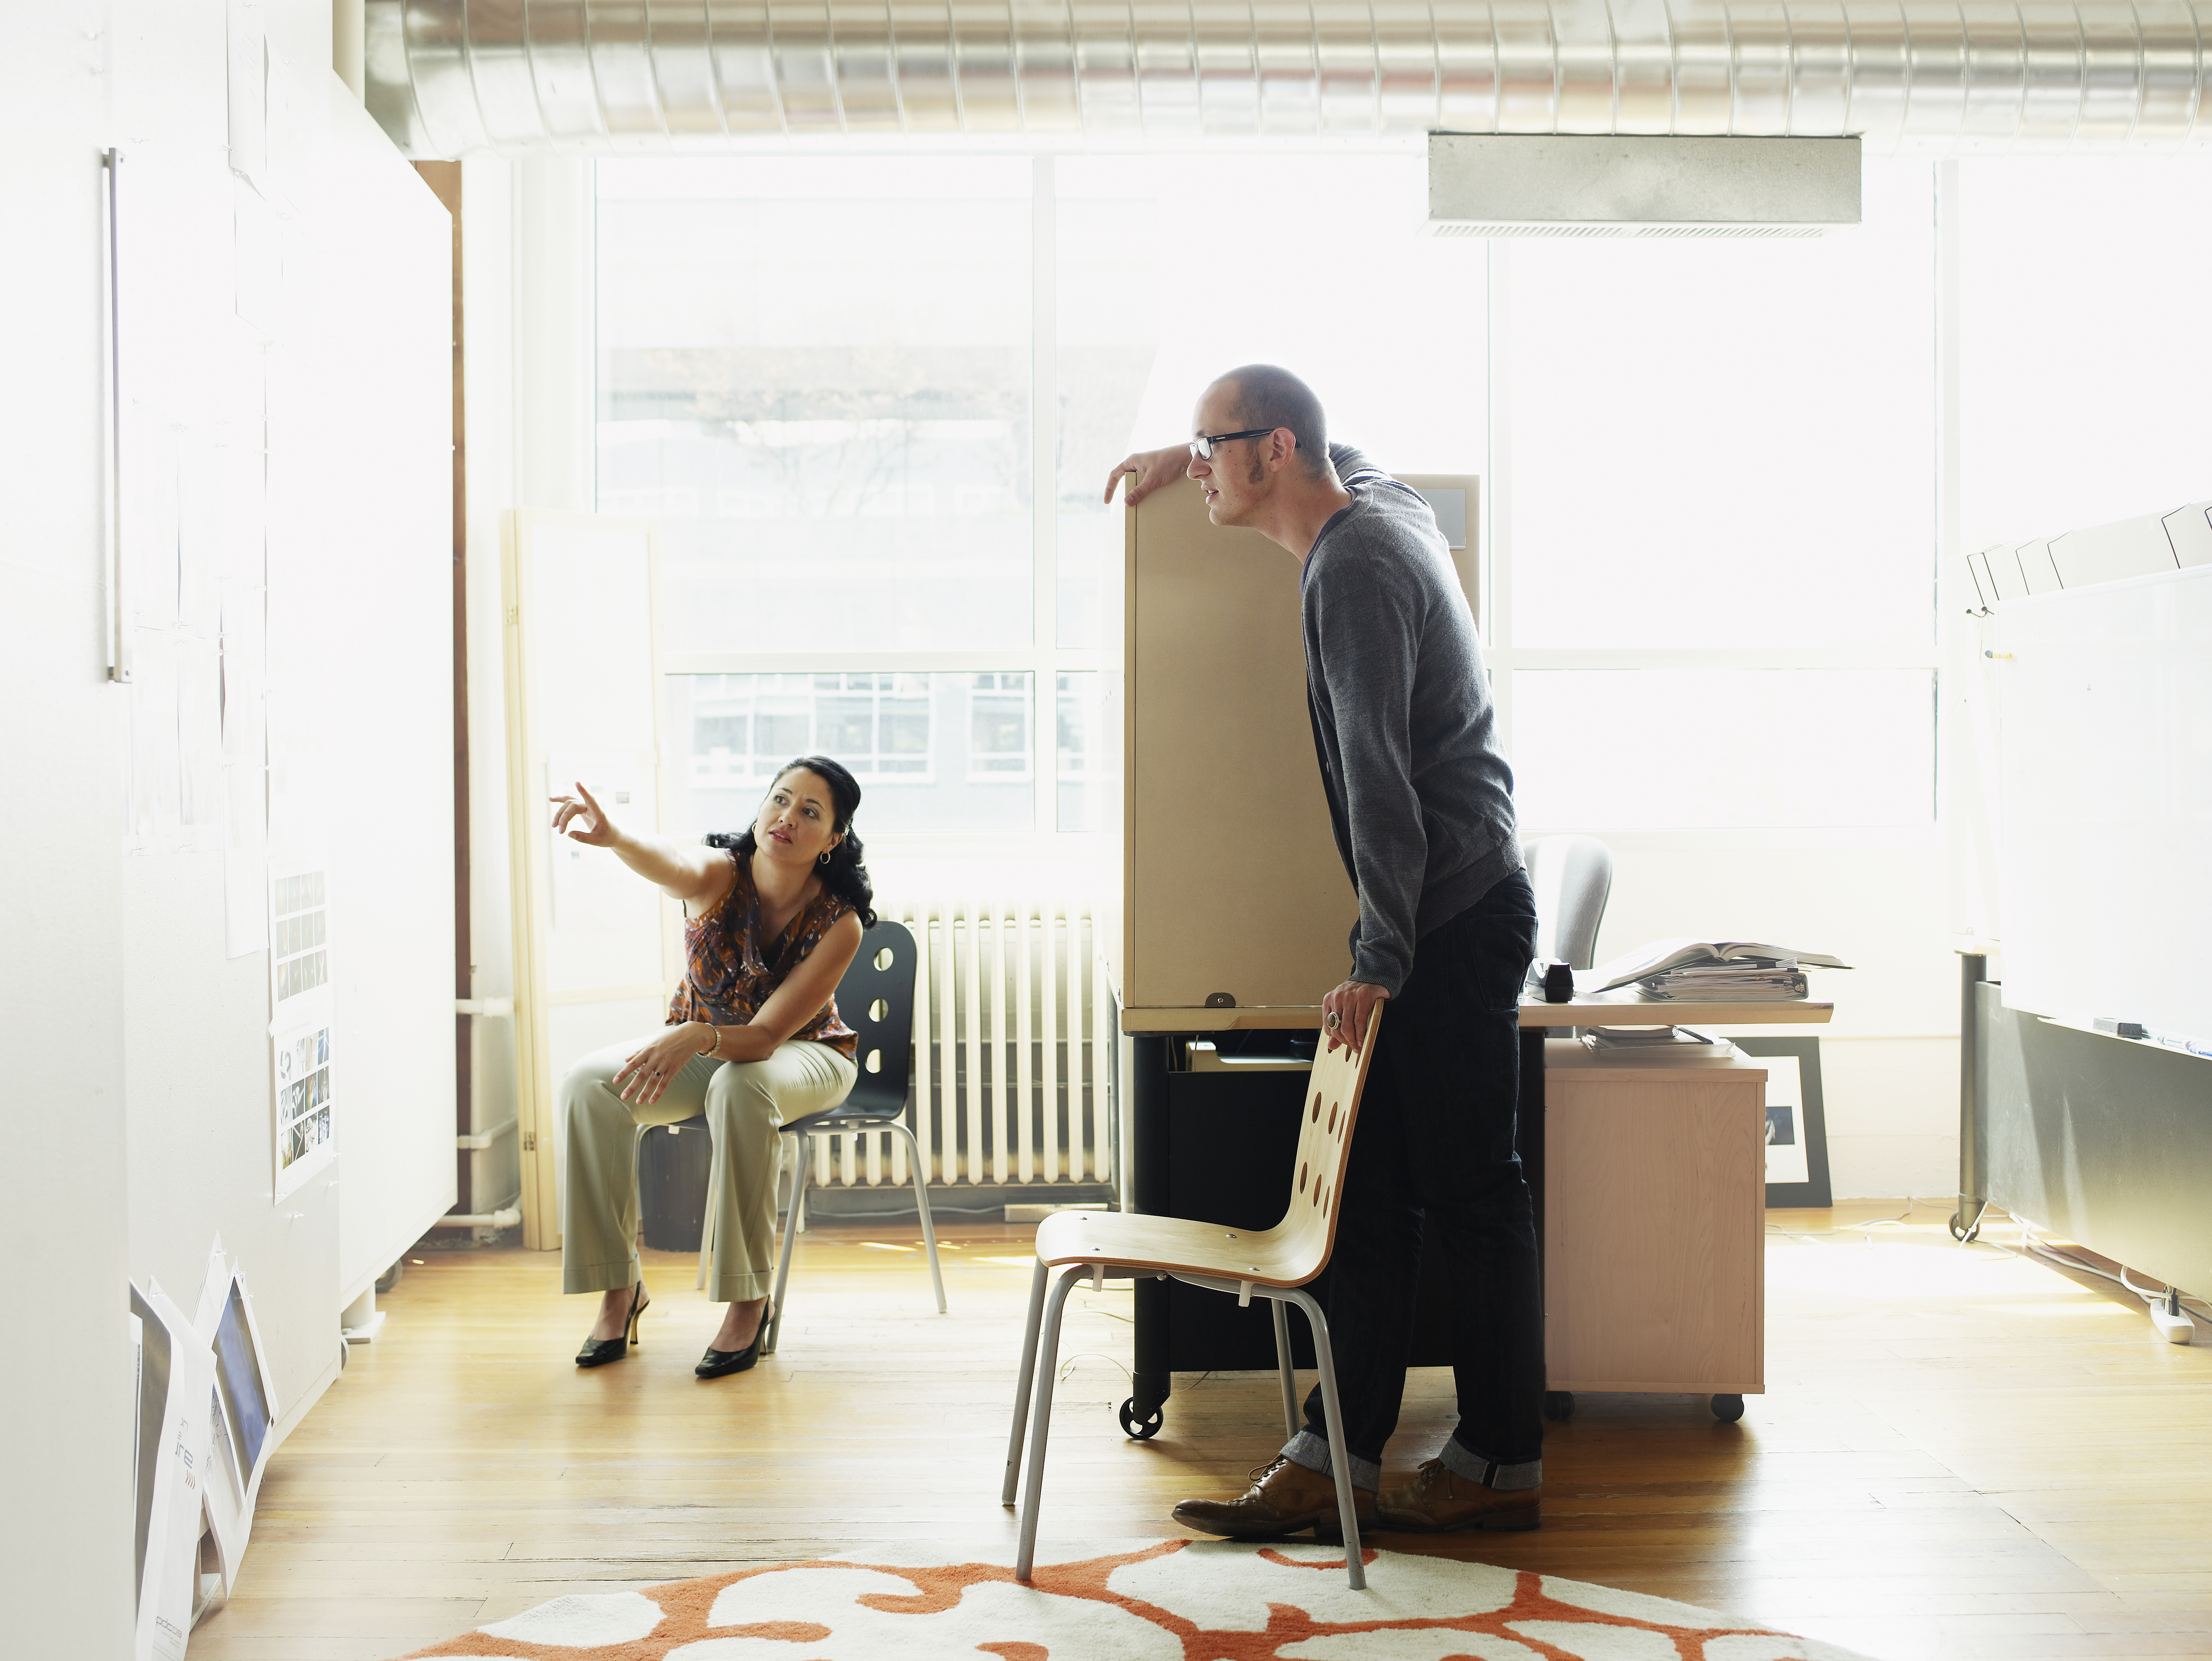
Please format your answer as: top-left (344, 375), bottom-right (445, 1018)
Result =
top-left (1000, 1004), bottom-right (1383, 1590)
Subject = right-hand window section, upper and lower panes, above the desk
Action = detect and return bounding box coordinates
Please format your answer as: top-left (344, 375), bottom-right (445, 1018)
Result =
top-left (1491, 162), bottom-right (1938, 830)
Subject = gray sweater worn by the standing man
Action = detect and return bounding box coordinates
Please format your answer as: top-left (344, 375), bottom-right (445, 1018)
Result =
top-left (1298, 445), bottom-right (1522, 995)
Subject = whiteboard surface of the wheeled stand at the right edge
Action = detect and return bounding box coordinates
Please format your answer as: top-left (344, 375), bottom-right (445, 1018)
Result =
top-left (1991, 566), bottom-right (2212, 1039)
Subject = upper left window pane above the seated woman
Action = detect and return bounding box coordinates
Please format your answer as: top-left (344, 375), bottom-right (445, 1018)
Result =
top-left (597, 157), bottom-right (1033, 652)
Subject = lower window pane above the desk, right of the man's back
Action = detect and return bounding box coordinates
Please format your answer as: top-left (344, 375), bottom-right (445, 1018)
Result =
top-left (1513, 670), bottom-right (1936, 831)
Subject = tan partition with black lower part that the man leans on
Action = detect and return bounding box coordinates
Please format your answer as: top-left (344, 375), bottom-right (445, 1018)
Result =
top-left (1102, 475), bottom-right (1542, 1435)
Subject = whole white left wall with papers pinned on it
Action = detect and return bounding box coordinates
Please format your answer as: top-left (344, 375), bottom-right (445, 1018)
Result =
top-left (0, 0), bottom-right (454, 1661)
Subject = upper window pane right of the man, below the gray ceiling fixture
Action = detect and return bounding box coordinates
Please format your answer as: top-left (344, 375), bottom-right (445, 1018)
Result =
top-left (1509, 162), bottom-right (1936, 646)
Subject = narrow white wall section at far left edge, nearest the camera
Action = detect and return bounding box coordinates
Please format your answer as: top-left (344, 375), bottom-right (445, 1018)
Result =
top-left (0, 0), bottom-right (135, 1661)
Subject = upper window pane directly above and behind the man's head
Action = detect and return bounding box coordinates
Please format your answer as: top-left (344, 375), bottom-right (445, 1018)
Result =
top-left (1055, 150), bottom-right (1487, 646)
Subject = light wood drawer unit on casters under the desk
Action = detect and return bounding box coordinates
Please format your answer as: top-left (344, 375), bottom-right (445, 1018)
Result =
top-left (1544, 1039), bottom-right (1767, 1395)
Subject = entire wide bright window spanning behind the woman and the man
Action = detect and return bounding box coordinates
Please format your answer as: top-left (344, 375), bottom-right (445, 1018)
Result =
top-left (597, 150), bottom-right (1936, 834)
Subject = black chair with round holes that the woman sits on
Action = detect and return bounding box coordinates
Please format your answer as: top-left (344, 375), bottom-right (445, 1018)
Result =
top-left (761, 920), bottom-right (945, 1356)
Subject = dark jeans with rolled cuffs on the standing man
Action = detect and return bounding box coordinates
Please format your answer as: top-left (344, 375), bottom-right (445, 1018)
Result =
top-left (1301, 871), bottom-right (1544, 1486)
